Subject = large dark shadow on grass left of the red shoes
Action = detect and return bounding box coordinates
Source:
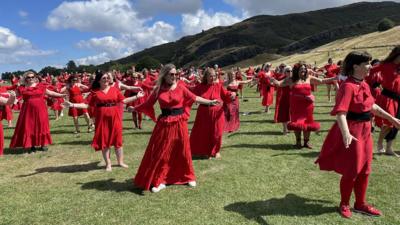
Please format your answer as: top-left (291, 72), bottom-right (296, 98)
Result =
top-left (224, 194), bottom-right (337, 225)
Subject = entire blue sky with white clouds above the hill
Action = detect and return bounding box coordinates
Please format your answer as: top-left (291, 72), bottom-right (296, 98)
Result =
top-left (0, 0), bottom-right (400, 73)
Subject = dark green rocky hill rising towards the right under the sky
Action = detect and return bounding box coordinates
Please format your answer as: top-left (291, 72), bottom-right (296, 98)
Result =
top-left (99, 2), bottom-right (400, 69)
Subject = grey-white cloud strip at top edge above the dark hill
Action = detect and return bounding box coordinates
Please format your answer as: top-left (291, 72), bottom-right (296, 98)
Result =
top-left (223, 0), bottom-right (400, 17)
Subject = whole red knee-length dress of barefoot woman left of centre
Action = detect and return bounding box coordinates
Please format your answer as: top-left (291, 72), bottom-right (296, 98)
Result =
top-left (89, 87), bottom-right (124, 151)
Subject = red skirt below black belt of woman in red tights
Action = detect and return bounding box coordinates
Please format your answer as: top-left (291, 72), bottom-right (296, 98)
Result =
top-left (316, 120), bottom-right (373, 178)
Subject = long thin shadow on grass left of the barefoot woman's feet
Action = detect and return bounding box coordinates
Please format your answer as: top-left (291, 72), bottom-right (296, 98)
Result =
top-left (16, 162), bottom-right (104, 177)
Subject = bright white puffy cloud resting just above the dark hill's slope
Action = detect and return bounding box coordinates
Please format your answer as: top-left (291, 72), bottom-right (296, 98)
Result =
top-left (181, 10), bottom-right (243, 35)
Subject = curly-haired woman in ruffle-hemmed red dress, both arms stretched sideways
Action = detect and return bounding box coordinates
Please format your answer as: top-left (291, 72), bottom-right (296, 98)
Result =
top-left (271, 63), bottom-right (337, 148)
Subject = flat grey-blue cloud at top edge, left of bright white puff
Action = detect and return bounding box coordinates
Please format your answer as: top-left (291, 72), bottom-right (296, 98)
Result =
top-left (134, 0), bottom-right (202, 18)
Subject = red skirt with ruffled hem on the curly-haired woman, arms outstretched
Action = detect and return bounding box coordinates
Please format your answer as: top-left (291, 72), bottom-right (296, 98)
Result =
top-left (288, 95), bottom-right (321, 131)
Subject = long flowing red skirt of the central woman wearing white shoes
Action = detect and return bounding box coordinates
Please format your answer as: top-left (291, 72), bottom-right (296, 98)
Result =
top-left (134, 115), bottom-right (196, 190)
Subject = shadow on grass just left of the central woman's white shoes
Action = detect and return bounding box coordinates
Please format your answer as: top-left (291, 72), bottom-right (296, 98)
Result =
top-left (78, 178), bottom-right (144, 195)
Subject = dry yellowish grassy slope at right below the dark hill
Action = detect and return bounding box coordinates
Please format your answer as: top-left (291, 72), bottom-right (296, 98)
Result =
top-left (234, 26), bottom-right (400, 68)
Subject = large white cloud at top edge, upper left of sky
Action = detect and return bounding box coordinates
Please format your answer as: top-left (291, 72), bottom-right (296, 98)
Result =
top-left (46, 0), bottom-right (145, 32)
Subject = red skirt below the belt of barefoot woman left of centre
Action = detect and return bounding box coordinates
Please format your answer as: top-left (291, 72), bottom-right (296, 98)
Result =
top-left (92, 105), bottom-right (122, 151)
